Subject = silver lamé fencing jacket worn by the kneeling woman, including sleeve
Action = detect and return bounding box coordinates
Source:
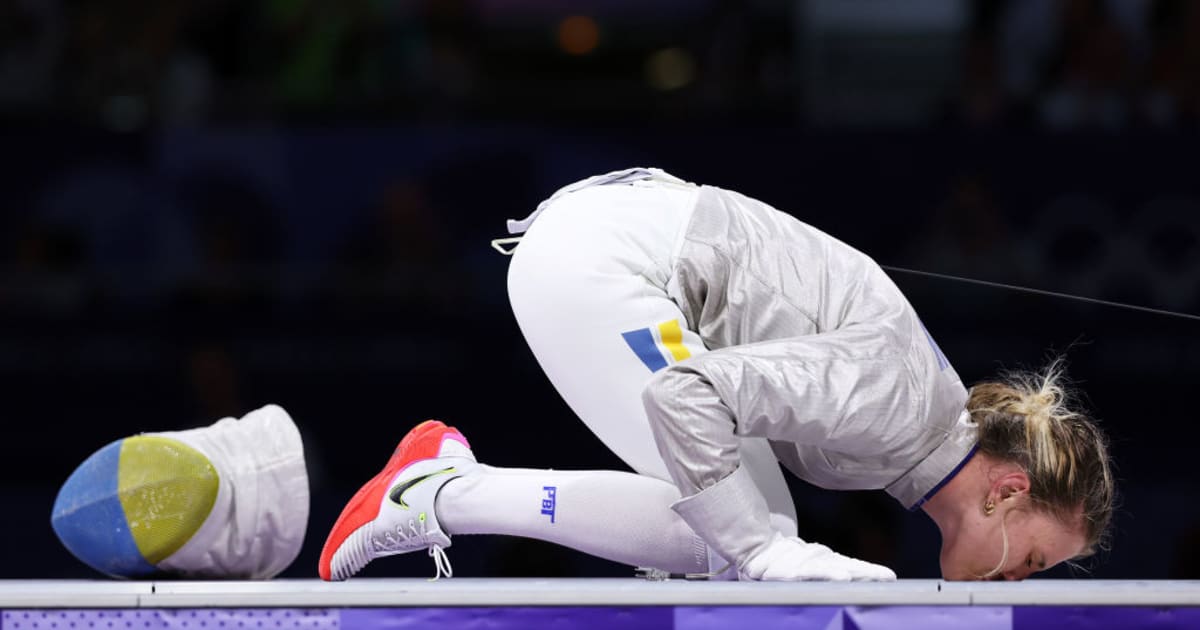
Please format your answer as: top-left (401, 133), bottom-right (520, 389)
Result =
top-left (643, 178), bottom-right (976, 509)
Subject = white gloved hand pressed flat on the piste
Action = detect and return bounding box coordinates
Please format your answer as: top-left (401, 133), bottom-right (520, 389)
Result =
top-left (740, 536), bottom-right (896, 582)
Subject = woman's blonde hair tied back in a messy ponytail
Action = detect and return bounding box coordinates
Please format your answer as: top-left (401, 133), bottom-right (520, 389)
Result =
top-left (967, 358), bottom-right (1116, 557)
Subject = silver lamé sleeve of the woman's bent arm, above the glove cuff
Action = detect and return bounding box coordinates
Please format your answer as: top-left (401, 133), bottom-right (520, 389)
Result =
top-left (642, 330), bottom-right (897, 497)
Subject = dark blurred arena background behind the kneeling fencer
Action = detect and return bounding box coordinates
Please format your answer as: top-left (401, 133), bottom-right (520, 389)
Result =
top-left (0, 0), bottom-right (1200, 578)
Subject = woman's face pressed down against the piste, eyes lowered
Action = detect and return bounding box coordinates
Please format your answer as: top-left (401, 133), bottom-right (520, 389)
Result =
top-left (941, 494), bottom-right (1085, 580)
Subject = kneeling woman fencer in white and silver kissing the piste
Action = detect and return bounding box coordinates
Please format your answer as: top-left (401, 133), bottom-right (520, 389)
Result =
top-left (319, 168), bottom-right (1114, 581)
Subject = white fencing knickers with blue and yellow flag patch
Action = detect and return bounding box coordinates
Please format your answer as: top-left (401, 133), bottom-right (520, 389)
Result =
top-left (508, 168), bottom-right (797, 554)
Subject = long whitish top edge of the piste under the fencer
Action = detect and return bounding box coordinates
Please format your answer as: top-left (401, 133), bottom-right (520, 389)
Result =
top-left (0, 577), bottom-right (1200, 608)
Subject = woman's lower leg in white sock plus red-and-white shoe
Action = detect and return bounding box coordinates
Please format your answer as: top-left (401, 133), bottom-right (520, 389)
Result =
top-left (318, 420), bottom-right (707, 581)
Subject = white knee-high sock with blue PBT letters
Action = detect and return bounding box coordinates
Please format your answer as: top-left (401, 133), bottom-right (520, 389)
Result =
top-left (436, 466), bottom-right (708, 572)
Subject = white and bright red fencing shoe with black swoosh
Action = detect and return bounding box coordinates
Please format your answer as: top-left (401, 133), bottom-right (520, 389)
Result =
top-left (318, 420), bottom-right (479, 581)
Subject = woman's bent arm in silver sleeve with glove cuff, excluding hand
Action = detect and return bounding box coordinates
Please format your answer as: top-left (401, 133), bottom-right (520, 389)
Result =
top-left (642, 332), bottom-right (905, 577)
